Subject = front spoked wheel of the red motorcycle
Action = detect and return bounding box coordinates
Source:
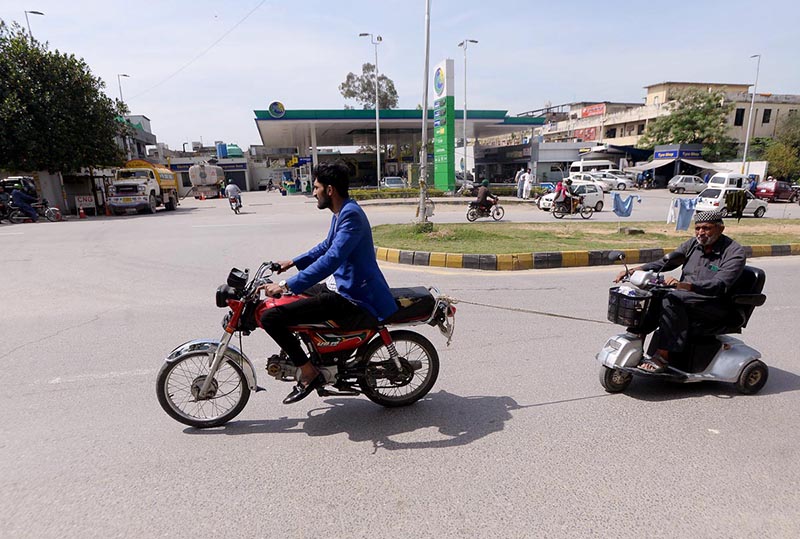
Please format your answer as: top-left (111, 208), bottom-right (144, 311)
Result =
top-left (156, 354), bottom-right (250, 429)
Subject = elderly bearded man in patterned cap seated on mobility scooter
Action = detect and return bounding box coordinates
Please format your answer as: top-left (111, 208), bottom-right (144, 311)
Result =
top-left (616, 211), bottom-right (745, 373)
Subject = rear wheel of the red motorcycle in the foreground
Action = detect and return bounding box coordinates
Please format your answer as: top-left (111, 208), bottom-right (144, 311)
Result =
top-left (359, 330), bottom-right (439, 408)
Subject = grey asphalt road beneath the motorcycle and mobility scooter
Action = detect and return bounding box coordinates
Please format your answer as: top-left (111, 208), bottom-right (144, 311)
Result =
top-left (0, 193), bottom-right (800, 538)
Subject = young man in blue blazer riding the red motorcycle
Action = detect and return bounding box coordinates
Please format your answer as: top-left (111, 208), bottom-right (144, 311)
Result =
top-left (261, 161), bottom-right (397, 404)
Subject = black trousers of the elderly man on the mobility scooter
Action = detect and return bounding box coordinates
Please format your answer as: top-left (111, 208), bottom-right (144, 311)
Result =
top-left (637, 290), bottom-right (730, 353)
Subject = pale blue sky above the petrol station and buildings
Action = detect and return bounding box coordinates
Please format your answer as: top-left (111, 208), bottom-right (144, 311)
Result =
top-left (0, 0), bottom-right (800, 148)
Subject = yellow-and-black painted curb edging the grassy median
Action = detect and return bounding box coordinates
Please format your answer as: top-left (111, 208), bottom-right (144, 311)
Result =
top-left (375, 243), bottom-right (800, 271)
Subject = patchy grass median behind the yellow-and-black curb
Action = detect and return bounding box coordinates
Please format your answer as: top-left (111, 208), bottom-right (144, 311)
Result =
top-left (372, 218), bottom-right (800, 254)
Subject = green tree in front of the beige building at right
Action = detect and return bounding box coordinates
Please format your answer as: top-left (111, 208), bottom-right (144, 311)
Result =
top-left (639, 88), bottom-right (736, 159)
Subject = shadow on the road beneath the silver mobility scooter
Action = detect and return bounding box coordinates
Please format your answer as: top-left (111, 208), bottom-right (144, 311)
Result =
top-left (625, 367), bottom-right (800, 402)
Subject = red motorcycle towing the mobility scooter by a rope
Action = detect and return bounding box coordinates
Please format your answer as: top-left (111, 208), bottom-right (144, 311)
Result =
top-left (156, 262), bottom-right (456, 428)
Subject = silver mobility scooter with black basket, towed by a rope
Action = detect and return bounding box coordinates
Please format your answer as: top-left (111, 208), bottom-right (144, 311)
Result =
top-left (596, 251), bottom-right (769, 394)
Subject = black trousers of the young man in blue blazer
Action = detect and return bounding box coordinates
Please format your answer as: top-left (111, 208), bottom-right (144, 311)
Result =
top-left (261, 284), bottom-right (378, 367)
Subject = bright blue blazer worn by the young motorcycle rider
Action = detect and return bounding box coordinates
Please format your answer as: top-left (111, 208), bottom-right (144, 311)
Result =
top-left (286, 198), bottom-right (397, 320)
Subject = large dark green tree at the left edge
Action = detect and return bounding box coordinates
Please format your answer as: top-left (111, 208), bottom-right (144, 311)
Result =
top-left (0, 20), bottom-right (128, 172)
